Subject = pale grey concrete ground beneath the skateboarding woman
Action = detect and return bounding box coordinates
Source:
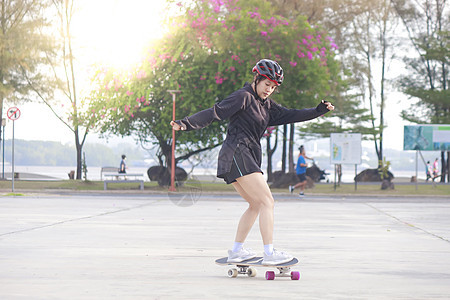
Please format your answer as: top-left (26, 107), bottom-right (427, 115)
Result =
top-left (0, 192), bottom-right (450, 300)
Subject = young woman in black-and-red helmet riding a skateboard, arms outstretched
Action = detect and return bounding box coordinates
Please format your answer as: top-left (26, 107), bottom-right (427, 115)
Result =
top-left (170, 59), bottom-right (334, 265)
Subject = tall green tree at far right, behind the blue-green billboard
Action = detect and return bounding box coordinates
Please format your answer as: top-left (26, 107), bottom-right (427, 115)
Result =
top-left (392, 0), bottom-right (450, 182)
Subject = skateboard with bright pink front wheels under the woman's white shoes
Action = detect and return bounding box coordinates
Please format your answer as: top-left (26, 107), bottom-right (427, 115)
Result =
top-left (216, 257), bottom-right (300, 280)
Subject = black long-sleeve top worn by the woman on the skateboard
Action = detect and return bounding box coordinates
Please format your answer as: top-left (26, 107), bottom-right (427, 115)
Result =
top-left (176, 83), bottom-right (328, 178)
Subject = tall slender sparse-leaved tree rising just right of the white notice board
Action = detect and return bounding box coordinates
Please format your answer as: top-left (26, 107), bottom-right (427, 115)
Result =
top-left (332, 0), bottom-right (396, 166)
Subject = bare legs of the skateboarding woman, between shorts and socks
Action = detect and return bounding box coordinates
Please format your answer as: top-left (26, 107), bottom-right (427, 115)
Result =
top-left (233, 173), bottom-right (274, 245)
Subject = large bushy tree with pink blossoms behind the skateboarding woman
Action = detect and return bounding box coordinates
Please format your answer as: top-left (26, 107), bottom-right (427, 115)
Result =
top-left (90, 0), bottom-right (339, 180)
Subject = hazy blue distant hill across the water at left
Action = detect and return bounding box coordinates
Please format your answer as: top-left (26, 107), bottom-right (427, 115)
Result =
top-left (0, 140), bottom-right (146, 167)
